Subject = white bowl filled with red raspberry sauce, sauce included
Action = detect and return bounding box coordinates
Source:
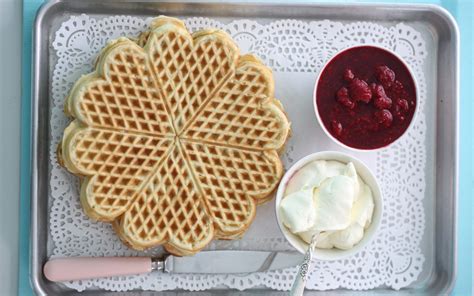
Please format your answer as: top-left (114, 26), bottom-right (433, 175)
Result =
top-left (314, 45), bottom-right (418, 150)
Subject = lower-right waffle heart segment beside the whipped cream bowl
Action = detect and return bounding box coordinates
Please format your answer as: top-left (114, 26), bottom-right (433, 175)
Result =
top-left (182, 141), bottom-right (283, 239)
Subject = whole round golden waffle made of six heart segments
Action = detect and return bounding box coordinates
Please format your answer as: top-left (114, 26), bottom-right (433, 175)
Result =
top-left (58, 17), bottom-right (289, 255)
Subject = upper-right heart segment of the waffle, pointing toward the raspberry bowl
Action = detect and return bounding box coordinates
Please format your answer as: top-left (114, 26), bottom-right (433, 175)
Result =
top-left (184, 55), bottom-right (289, 150)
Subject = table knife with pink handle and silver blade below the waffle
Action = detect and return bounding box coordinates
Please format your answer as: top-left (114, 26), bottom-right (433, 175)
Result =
top-left (43, 250), bottom-right (303, 282)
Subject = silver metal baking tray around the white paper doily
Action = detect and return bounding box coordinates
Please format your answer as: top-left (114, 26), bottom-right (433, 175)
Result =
top-left (30, 0), bottom-right (459, 295)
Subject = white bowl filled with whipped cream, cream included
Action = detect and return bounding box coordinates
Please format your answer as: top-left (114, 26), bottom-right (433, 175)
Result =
top-left (275, 151), bottom-right (382, 260)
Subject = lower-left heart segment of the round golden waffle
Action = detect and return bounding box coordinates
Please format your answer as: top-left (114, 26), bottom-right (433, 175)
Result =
top-left (60, 121), bottom-right (173, 221)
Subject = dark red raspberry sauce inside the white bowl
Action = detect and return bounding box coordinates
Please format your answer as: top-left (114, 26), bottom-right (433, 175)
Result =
top-left (316, 46), bottom-right (417, 150)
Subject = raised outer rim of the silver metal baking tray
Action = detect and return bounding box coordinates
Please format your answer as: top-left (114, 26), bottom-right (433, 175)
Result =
top-left (29, 0), bottom-right (460, 295)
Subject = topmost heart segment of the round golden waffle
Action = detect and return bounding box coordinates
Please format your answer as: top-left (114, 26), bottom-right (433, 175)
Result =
top-left (145, 18), bottom-right (239, 134)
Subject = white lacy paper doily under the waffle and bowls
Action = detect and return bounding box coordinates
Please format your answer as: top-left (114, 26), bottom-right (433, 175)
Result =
top-left (49, 15), bottom-right (426, 291)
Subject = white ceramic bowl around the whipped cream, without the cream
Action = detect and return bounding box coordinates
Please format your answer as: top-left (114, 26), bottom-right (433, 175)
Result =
top-left (275, 151), bottom-right (383, 260)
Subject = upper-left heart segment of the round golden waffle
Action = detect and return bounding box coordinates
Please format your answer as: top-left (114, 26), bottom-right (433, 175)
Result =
top-left (81, 46), bottom-right (173, 135)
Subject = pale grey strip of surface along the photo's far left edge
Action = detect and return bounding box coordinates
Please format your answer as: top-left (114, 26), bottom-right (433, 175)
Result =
top-left (0, 0), bottom-right (22, 296)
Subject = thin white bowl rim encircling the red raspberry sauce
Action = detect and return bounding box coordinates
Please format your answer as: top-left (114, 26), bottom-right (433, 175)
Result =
top-left (313, 44), bottom-right (420, 151)
